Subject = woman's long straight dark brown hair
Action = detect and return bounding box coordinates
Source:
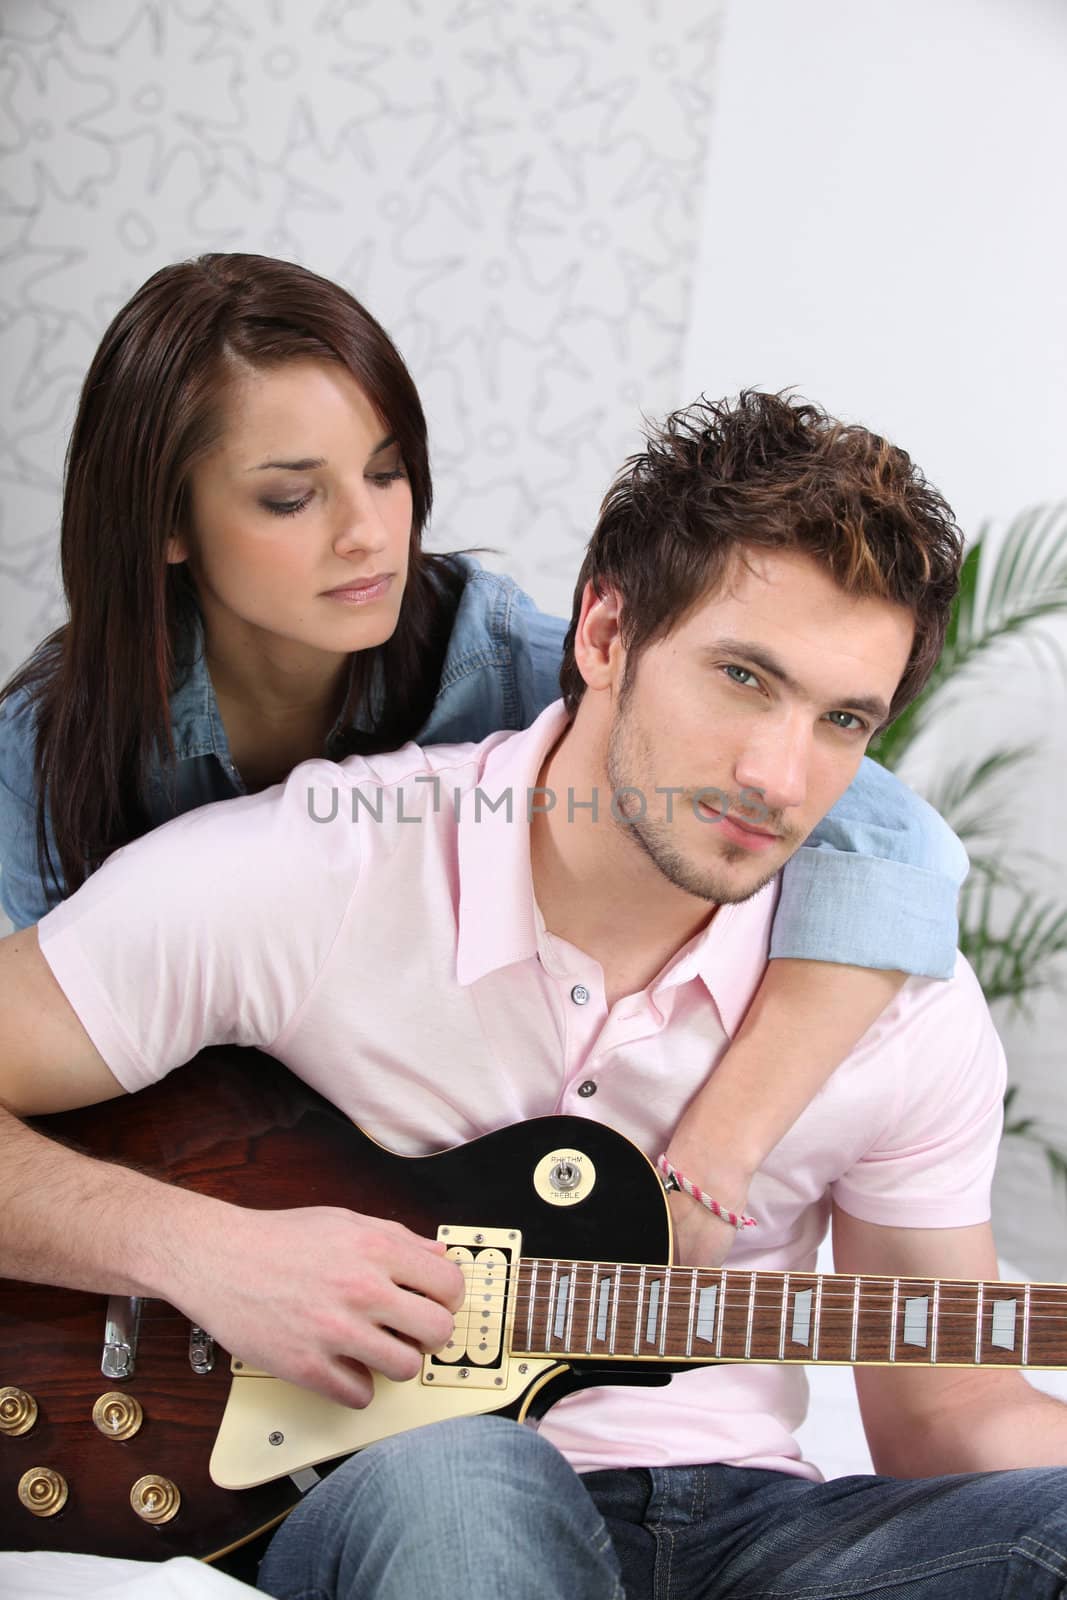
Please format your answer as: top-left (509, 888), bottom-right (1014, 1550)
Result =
top-left (0, 254), bottom-right (462, 893)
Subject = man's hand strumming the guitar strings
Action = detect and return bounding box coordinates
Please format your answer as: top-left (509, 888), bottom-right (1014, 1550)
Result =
top-left (175, 1206), bottom-right (466, 1406)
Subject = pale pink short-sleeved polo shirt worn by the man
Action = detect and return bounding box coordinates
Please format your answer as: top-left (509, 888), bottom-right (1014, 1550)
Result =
top-left (40, 702), bottom-right (1005, 1477)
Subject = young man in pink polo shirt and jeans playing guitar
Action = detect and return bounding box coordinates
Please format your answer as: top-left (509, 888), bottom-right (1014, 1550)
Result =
top-left (0, 395), bottom-right (1067, 1600)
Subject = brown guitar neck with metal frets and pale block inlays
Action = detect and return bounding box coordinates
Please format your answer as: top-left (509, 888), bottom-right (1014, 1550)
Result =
top-left (512, 1258), bottom-right (1067, 1366)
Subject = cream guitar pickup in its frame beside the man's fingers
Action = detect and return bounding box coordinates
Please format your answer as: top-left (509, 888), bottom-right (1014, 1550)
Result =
top-left (422, 1226), bottom-right (522, 1389)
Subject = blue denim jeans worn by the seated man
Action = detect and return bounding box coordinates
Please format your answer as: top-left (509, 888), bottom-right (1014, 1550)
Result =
top-left (259, 1416), bottom-right (1067, 1600)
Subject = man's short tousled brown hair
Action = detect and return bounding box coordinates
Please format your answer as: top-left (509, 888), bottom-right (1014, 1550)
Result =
top-left (560, 389), bottom-right (963, 717)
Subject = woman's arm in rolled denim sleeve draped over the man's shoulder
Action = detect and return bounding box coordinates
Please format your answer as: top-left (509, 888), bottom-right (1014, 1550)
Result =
top-left (665, 760), bottom-right (968, 1266)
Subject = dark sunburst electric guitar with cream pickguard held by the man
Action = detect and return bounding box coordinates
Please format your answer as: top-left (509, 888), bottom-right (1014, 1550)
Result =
top-left (0, 1050), bottom-right (1067, 1560)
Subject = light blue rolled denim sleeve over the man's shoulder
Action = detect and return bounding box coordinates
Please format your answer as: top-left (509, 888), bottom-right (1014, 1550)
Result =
top-left (771, 758), bottom-right (969, 978)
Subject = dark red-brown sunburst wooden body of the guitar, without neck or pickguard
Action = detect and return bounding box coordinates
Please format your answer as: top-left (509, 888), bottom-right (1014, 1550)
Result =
top-left (0, 1050), bottom-right (669, 1560)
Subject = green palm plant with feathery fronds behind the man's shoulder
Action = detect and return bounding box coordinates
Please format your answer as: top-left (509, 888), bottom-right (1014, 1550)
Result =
top-left (870, 502), bottom-right (1067, 1187)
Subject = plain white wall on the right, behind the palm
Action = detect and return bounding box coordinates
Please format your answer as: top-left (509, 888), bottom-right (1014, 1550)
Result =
top-left (685, 0), bottom-right (1067, 1277)
